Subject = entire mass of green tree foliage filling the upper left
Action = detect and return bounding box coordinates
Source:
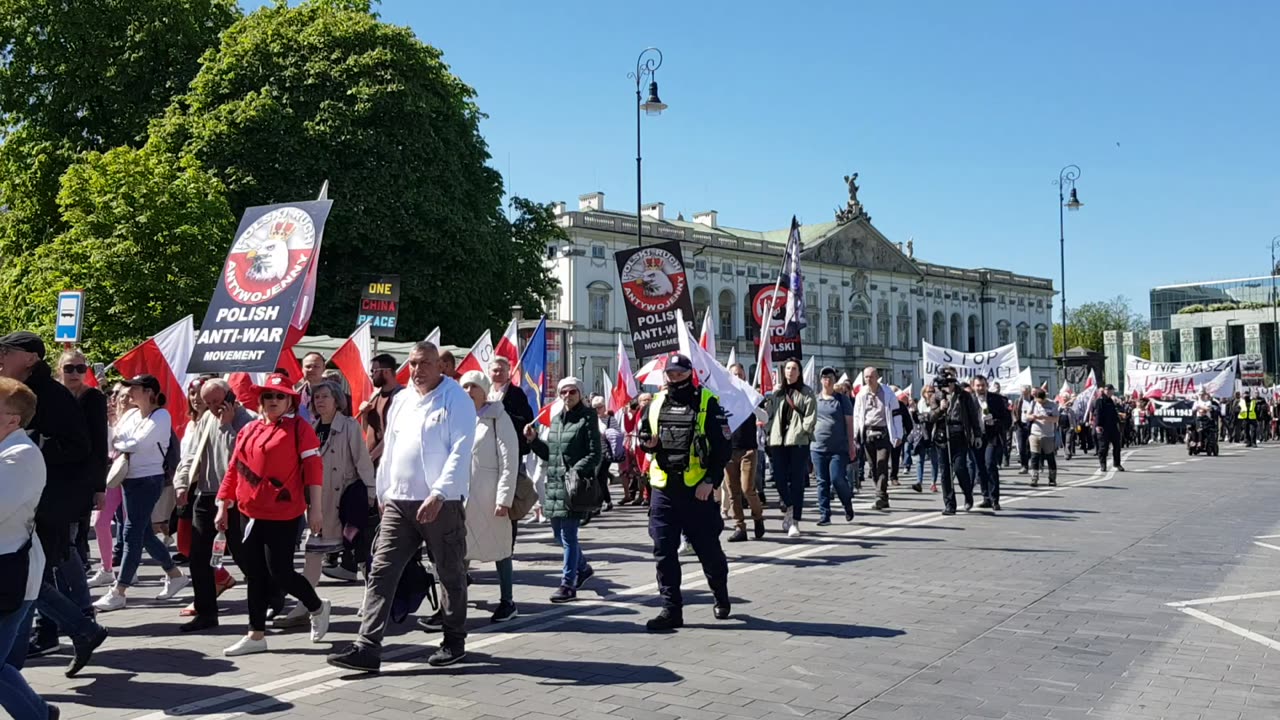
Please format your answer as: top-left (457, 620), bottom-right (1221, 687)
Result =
top-left (0, 0), bottom-right (563, 352)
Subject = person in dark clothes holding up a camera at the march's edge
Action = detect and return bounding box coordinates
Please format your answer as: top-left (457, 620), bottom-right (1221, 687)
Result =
top-left (929, 368), bottom-right (983, 515)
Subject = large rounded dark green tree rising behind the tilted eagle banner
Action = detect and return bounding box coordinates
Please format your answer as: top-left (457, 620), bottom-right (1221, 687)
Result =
top-left (152, 0), bottom-right (529, 340)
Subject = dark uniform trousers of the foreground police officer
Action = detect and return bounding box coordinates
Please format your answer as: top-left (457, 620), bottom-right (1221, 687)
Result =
top-left (649, 473), bottom-right (728, 616)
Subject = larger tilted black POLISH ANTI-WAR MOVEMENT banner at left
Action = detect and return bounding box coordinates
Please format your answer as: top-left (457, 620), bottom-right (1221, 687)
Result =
top-left (187, 200), bottom-right (333, 374)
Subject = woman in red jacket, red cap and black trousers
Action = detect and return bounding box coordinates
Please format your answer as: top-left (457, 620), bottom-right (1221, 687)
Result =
top-left (214, 374), bottom-right (329, 657)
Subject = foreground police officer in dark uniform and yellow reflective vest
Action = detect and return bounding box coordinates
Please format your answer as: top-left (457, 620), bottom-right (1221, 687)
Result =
top-left (639, 352), bottom-right (731, 633)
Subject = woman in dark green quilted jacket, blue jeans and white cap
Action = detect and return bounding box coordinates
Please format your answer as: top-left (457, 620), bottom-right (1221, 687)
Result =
top-left (525, 377), bottom-right (604, 602)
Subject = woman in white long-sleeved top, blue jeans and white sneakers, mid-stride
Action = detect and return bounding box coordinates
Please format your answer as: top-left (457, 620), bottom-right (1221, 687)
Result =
top-left (93, 375), bottom-right (191, 612)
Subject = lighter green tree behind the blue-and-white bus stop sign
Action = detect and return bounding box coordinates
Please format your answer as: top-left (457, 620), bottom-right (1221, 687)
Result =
top-left (0, 147), bottom-right (236, 359)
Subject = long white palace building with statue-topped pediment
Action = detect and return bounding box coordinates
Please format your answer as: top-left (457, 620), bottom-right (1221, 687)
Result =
top-left (547, 176), bottom-right (1057, 392)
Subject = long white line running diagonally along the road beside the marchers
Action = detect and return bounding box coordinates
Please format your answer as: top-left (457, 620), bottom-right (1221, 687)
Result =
top-left (149, 450), bottom-right (1137, 720)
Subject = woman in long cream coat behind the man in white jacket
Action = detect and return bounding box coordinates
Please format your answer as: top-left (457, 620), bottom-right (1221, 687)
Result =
top-left (461, 370), bottom-right (520, 623)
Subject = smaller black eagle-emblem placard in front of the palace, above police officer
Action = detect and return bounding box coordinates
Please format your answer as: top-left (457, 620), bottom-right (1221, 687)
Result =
top-left (613, 241), bottom-right (694, 360)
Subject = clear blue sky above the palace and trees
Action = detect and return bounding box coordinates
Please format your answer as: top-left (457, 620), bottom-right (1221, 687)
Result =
top-left (254, 0), bottom-right (1280, 314)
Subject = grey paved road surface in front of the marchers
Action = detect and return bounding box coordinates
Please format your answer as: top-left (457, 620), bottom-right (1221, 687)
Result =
top-left (27, 446), bottom-right (1280, 720)
